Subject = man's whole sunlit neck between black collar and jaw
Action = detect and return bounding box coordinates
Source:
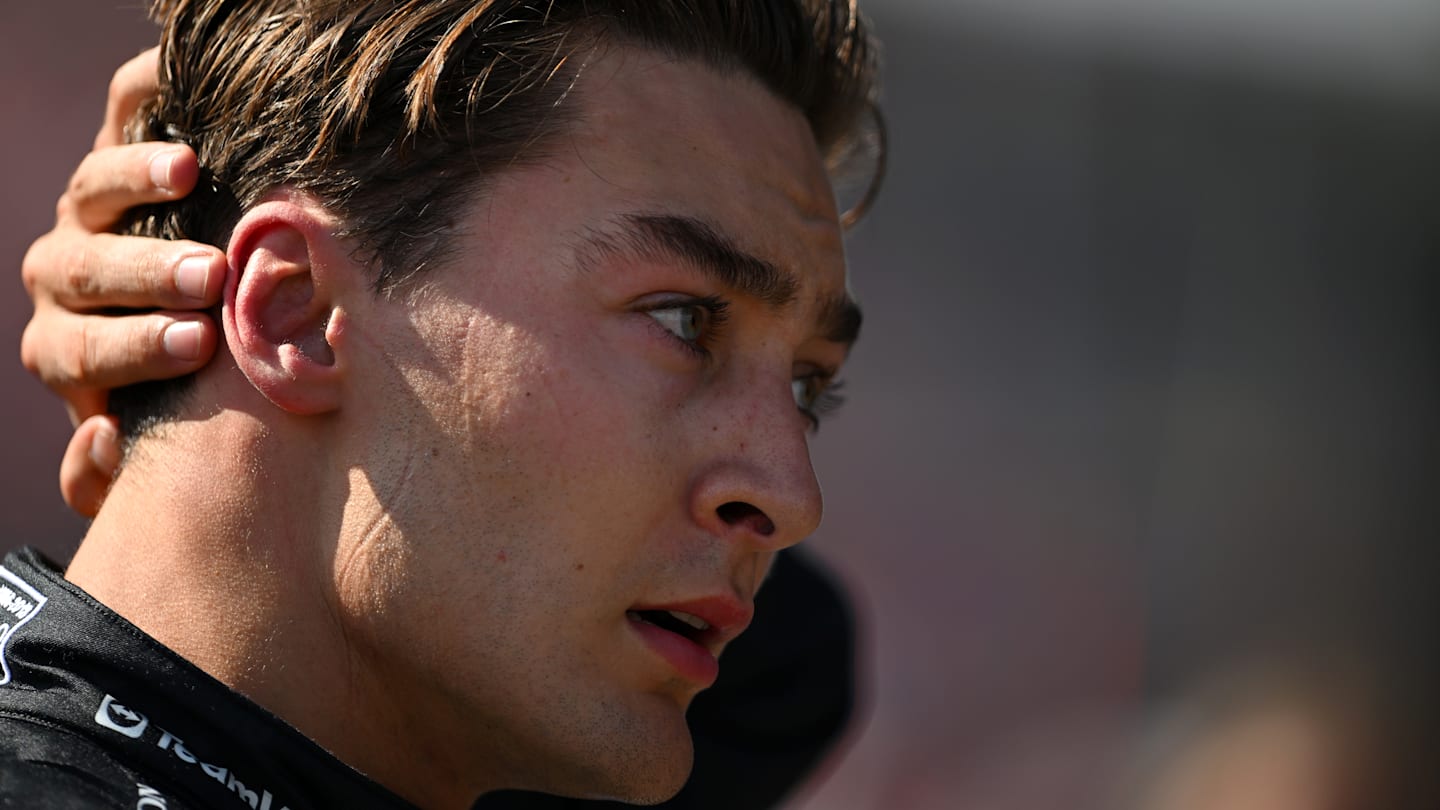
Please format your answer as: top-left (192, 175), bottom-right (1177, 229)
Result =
top-left (66, 411), bottom-right (495, 807)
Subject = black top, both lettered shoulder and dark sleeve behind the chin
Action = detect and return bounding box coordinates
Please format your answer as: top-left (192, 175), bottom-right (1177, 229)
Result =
top-left (0, 549), bottom-right (852, 810)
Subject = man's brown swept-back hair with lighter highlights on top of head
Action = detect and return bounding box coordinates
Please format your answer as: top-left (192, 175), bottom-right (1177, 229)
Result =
top-left (111, 0), bottom-right (876, 438)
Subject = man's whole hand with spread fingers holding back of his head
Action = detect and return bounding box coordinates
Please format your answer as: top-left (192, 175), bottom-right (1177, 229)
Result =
top-left (20, 49), bottom-right (225, 517)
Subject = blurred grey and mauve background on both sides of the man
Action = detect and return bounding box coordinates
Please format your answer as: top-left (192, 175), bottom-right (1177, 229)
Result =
top-left (0, 0), bottom-right (1440, 810)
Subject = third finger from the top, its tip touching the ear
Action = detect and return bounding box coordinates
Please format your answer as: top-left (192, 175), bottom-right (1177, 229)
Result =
top-left (20, 231), bottom-right (226, 310)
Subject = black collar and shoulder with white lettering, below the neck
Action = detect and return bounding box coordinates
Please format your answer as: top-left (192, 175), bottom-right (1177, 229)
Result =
top-left (0, 549), bottom-right (410, 810)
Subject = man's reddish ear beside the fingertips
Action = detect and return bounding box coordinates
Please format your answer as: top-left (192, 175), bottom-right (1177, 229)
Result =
top-left (222, 190), bottom-right (359, 415)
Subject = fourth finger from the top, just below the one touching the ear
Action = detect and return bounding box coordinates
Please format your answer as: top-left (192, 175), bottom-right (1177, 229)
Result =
top-left (20, 310), bottom-right (219, 396)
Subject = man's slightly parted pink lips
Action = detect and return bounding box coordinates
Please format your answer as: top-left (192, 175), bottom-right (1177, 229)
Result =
top-left (625, 597), bottom-right (755, 687)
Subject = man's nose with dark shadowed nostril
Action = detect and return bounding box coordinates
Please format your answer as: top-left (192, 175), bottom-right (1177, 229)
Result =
top-left (693, 386), bottom-right (824, 551)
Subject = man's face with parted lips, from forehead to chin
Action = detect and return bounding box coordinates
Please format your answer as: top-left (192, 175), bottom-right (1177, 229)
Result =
top-left (321, 48), bottom-right (858, 800)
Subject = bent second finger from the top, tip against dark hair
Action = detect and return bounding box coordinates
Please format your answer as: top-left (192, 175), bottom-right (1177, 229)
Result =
top-left (63, 143), bottom-right (200, 232)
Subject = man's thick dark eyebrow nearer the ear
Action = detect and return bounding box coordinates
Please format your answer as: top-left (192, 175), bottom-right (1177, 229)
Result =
top-left (576, 213), bottom-right (798, 310)
